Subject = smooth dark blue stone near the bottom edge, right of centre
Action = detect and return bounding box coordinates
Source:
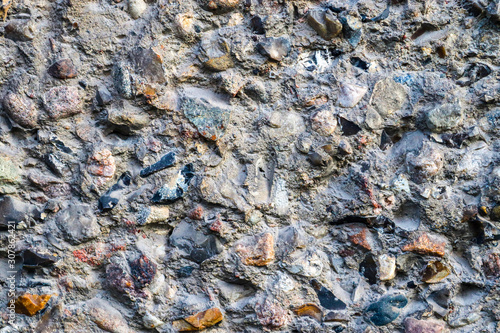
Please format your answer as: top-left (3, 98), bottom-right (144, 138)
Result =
top-left (365, 295), bottom-right (408, 326)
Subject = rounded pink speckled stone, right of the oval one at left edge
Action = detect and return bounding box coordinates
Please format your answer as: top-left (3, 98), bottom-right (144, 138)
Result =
top-left (44, 86), bottom-right (82, 120)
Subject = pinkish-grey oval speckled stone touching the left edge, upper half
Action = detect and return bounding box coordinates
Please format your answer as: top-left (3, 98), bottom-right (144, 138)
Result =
top-left (3, 92), bottom-right (38, 128)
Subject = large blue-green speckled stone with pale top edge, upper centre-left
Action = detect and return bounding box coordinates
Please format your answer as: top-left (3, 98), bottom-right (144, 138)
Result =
top-left (181, 88), bottom-right (231, 141)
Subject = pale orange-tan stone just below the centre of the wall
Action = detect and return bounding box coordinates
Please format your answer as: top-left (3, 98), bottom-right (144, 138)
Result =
top-left (236, 232), bottom-right (274, 266)
